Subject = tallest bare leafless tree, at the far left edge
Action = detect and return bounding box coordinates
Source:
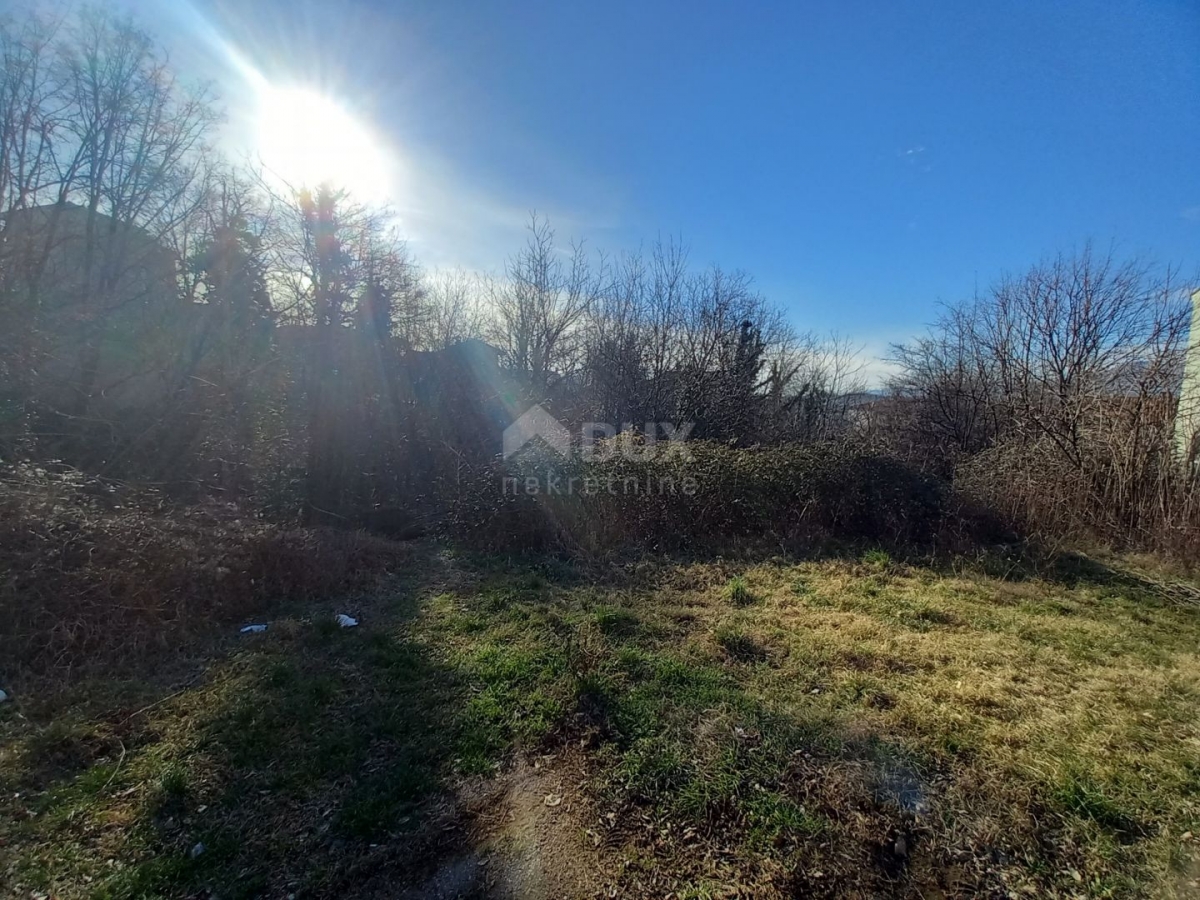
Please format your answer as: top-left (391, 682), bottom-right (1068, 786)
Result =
top-left (0, 10), bottom-right (217, 458)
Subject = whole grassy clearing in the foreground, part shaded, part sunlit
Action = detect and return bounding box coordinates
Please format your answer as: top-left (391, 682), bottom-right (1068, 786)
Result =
top-left (0, 545), bottom-right (1200, 900)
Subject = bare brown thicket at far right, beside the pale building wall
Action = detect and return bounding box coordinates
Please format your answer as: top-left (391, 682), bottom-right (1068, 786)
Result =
top-left (887, 247), bottom-right (1200, 551)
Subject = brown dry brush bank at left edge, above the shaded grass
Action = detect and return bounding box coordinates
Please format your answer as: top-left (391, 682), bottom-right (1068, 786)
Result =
top-left (0, 467), bottom-right (403, 678)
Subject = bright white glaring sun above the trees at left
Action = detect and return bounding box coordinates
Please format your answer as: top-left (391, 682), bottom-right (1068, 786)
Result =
top-left (257, 86), bottom-right (391, 202)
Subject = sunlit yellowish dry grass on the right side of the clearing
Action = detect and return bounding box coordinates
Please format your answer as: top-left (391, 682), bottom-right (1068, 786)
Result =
top-left (648, 560), bottom-right (1200, 896)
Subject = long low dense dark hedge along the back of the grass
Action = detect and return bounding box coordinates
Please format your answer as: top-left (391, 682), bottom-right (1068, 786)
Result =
top-left (449, 439), bottom-right (948, 553)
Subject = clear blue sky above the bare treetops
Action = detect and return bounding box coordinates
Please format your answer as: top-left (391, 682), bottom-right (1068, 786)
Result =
top-left (127, 0), bottom-right (1200, 376)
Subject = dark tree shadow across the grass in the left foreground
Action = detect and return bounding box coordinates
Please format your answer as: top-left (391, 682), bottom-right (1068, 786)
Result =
top-left (10, 626), bottom-right (472, 898)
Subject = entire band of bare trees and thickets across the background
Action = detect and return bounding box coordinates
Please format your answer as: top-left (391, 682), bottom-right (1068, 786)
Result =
top-left (0, 10), bottom-right (1200, 556)
